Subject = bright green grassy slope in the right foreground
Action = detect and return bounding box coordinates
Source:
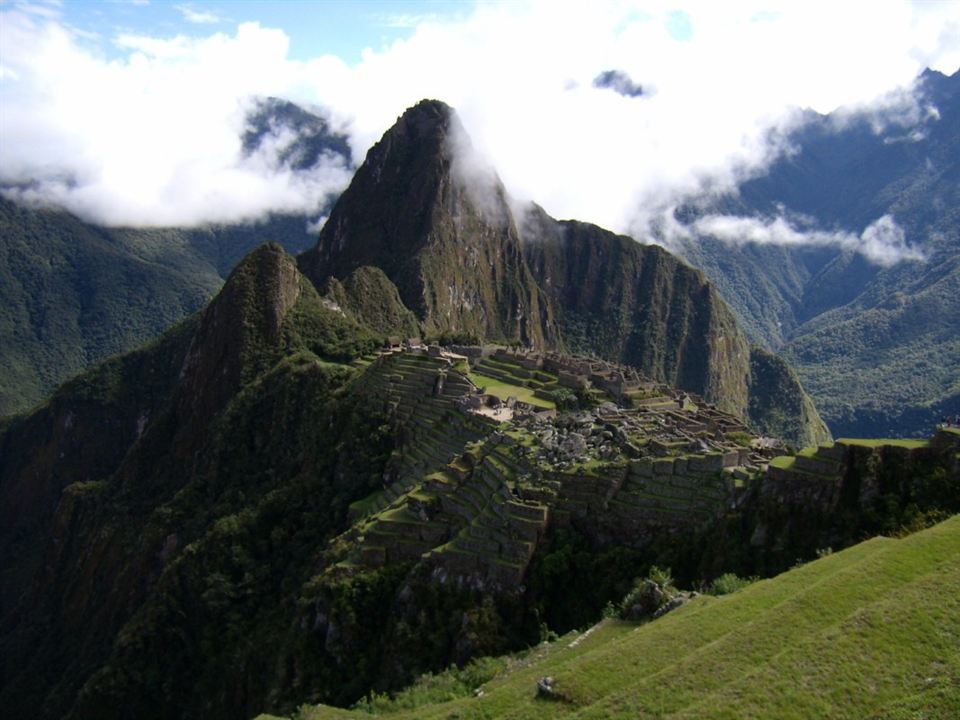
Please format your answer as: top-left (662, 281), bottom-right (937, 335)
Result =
top-left (290, 516), bottom-right (960, 720)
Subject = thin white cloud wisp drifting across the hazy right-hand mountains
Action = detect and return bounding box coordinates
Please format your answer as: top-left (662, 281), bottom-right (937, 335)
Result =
top-left (684, 215), bottom-right (924, 267)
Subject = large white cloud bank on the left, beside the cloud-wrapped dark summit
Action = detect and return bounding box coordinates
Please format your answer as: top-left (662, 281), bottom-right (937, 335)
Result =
top-left (0, 11), bottom-right (350, 225)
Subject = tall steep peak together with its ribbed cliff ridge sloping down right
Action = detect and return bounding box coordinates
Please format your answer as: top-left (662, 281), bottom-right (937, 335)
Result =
top-left (300, 101), bottom-right (827, 444)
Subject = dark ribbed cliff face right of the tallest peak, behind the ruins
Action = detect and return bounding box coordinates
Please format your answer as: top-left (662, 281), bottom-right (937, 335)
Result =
top-left (523, 208), bottom-right (749, 416)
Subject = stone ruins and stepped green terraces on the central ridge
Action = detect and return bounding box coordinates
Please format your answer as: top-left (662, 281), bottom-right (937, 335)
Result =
top-left (322, 349), bottom-right (782, 589)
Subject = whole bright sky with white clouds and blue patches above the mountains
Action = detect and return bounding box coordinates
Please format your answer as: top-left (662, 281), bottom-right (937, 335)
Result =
top-left (0, 0), bottom-right (960, 258)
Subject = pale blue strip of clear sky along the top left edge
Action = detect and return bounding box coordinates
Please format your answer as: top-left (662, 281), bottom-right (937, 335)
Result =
top-left (62, 0), bottom-right (472, 63)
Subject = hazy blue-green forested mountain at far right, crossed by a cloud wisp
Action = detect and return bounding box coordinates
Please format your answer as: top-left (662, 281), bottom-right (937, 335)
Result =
top-left (677, 70), bottom-right (960, 436)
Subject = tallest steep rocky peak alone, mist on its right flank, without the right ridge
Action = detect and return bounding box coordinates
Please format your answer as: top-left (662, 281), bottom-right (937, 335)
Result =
top-left (300, 100), bottom-right (556, 347)
